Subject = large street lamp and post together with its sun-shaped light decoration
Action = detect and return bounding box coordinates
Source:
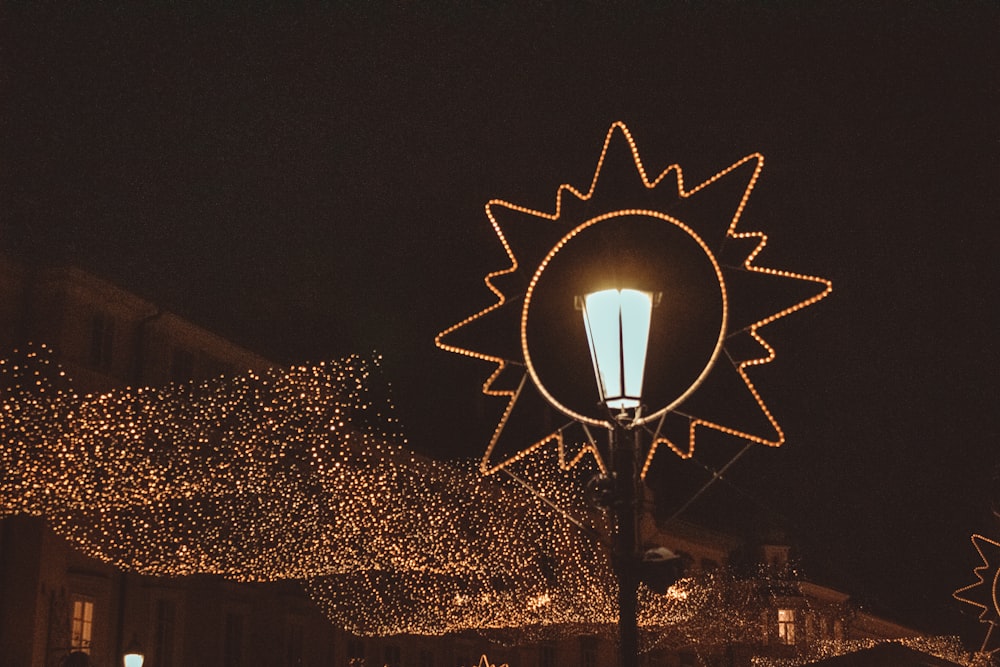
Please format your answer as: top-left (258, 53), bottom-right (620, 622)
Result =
top-left (435, 123), bottom-right (832, 667)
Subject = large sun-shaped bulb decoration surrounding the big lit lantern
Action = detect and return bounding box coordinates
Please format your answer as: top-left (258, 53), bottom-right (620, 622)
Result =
top-left (435, 122), bottom-right (832, 476)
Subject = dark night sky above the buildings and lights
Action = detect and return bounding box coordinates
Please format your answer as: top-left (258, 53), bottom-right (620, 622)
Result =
top-left (0, 1), bottom-right (1000, 634)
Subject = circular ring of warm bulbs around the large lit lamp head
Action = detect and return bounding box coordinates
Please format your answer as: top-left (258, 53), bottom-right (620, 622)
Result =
top-left (521, 209), bottom-right (729, 428)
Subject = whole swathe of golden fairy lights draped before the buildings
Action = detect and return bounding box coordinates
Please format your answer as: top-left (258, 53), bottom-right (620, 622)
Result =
top-left (0, 348), bottom-right (864, 646)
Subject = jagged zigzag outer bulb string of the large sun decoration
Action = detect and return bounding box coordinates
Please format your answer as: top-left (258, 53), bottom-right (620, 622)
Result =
top-left (434, 121), bottom-right (833, 477)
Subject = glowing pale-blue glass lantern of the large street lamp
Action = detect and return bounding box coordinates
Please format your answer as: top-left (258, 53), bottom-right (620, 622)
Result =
top-left (582, 289), bottom-right (653, 410)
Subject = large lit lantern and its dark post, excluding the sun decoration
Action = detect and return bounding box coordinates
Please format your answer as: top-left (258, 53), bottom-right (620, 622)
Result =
top-left (577, 289), bottom-right (658, 667)
